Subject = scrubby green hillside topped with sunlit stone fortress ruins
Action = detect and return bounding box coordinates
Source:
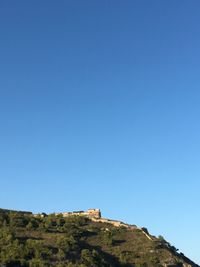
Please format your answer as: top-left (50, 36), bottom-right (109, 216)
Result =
top-left (0, 209), bottom-right (198, 267)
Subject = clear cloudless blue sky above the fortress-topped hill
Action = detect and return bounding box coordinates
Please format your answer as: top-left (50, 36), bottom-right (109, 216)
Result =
top-left (0, 0), bottom-right (200, 263)
